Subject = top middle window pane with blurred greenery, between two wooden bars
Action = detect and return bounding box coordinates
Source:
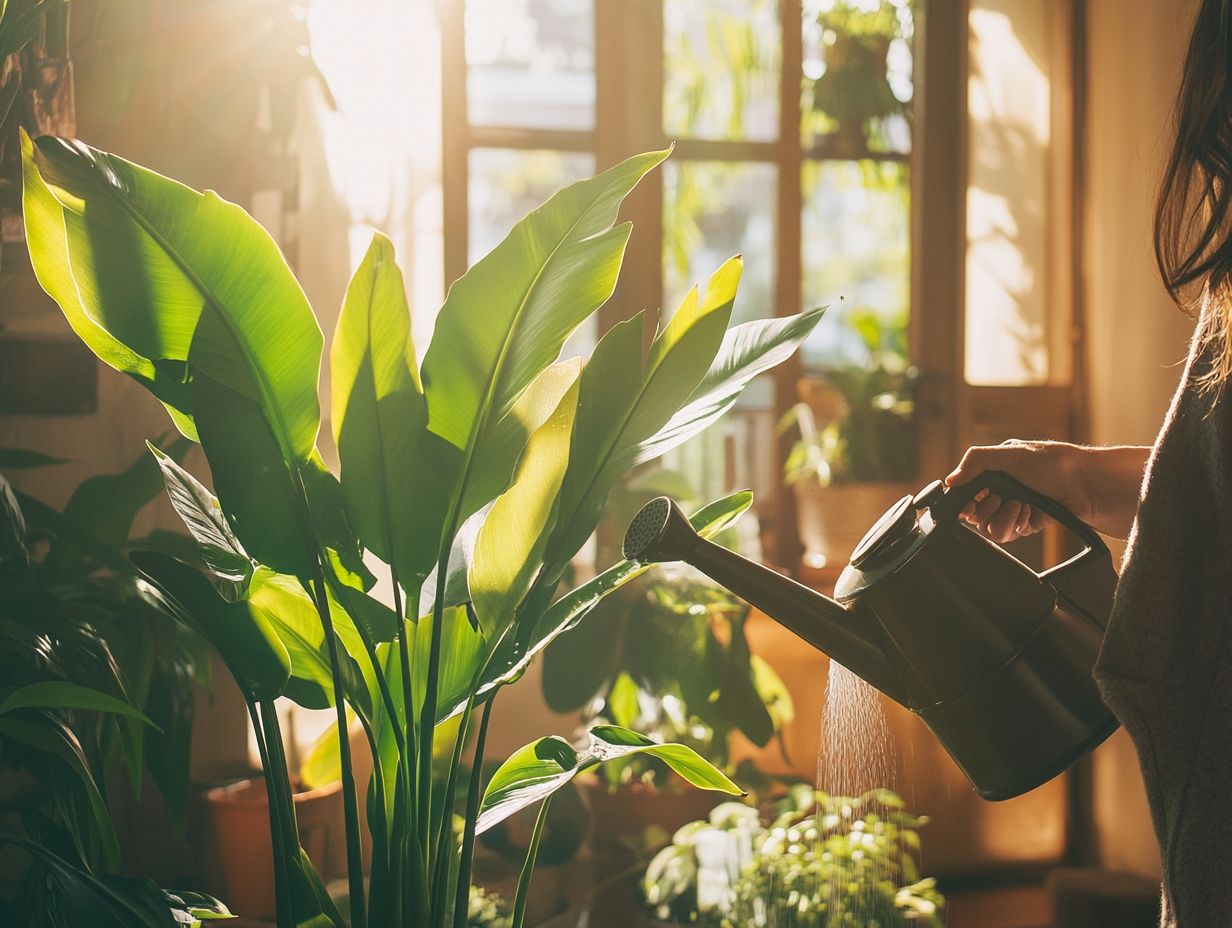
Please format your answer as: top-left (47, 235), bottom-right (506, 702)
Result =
top-left (663, 0), bottom-right (782, 140)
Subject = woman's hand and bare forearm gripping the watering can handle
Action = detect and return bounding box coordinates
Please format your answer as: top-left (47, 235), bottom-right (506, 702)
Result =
top-left (945, 440), bottom-right (1151, 543)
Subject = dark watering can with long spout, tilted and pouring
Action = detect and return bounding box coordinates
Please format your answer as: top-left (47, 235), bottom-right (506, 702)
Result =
top-left (623, 471), bottom-right (1117, 800)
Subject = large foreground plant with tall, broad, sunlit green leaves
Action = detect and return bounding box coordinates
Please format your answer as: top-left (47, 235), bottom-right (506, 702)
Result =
top-left (23, 130), bottom-right (819, 928)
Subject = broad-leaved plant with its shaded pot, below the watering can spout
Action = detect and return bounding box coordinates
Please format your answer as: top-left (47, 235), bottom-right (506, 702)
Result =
top-left (542, 566), bottom-right (793, 923)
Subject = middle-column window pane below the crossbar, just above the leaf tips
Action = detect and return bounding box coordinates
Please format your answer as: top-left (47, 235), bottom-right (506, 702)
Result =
top-left (663, 160), bottom-right (777, 320)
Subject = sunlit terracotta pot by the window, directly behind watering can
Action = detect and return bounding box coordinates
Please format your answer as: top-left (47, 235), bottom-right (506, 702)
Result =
top-left (792, 481), bottom-right (917, 569)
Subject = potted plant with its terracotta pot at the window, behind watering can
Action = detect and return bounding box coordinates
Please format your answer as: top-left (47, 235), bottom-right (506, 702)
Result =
top-left (779, 312), bottom-right (919, 569)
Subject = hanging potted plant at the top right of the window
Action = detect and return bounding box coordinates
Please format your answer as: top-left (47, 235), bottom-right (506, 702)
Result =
top-left (813, 0), bottom-right (907, 158)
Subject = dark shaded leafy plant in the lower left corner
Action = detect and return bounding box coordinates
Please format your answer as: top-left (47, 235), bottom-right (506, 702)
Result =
top-left (0, 439), bottom-right (225, 927)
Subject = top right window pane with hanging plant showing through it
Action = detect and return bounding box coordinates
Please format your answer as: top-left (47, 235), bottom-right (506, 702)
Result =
top-left (802, 0), bottom-right (915, 158)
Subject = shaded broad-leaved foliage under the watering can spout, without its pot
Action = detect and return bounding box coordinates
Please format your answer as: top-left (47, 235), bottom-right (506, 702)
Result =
top-left (542, 568), bottom-right (793, 788)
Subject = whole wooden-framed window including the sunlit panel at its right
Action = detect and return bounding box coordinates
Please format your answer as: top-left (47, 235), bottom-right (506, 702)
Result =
top-left (441, 0), bottom-right (1074, 564)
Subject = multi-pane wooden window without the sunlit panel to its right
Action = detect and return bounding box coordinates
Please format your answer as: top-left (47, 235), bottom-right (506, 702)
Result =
top-left (442, 0), bottom-right (914, 564)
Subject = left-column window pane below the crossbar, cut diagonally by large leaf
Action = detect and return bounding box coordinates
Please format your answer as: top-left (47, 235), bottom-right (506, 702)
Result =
top-left (467, 148), bottom-right (596, 357)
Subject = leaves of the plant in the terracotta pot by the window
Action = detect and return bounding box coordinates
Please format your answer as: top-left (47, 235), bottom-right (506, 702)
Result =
top-left (779, 312), bottom-right (919, 487)
